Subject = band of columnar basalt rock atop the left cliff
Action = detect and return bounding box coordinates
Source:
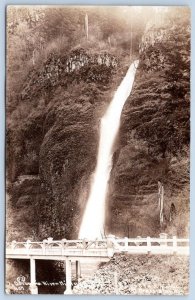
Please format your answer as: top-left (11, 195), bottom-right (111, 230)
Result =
top-left (21, 48), bottom-right (119, 100)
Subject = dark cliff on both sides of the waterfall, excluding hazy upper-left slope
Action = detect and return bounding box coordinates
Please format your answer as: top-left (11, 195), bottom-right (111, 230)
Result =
top-left (7, 14), bottom-right (190, 244)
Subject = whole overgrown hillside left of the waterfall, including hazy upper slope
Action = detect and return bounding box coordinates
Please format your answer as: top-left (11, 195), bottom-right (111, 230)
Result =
top-left (7, 7), bottom-right (150, 239)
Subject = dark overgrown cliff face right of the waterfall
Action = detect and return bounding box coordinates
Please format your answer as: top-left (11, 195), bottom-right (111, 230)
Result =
top-left (107, 16), bottom-right (190, 236)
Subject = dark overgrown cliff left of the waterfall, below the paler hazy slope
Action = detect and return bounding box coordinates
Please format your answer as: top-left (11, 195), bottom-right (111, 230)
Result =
top-left (7, 49), bottom-right (126, 240)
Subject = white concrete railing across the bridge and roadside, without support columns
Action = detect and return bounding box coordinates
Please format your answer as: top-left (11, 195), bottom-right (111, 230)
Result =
top-left (6, 234), bottom-right (189, 257)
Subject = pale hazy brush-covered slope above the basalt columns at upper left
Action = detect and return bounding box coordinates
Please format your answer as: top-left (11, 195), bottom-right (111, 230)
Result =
top-left (7, 6), bottom-right (150, 113)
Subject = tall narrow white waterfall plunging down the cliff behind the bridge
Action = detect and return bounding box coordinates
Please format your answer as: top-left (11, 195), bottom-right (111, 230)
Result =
top-left (79, 60), bottom-right (139, 239)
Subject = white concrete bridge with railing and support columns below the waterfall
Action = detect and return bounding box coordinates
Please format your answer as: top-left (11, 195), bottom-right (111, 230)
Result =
top-left (6, 234), bottom-right (189, 294)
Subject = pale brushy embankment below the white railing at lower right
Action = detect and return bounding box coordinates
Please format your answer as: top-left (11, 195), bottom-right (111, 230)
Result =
top-left (73, 254), bottom-right (189, 295)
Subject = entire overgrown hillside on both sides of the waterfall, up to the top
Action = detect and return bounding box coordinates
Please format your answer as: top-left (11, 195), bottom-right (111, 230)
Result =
top-left (7, 6), bottom-right (190, 239)
